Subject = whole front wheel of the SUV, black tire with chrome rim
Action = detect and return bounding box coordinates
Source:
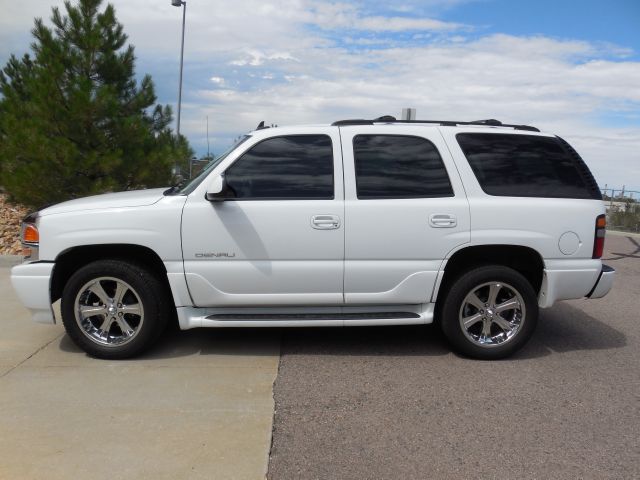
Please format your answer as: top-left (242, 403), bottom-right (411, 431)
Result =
top-left (61, 260), bottom-right (173, 360)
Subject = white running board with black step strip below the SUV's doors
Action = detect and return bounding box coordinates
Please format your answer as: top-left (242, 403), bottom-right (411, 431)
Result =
top-left (177, 304), bottom-right (433, 330)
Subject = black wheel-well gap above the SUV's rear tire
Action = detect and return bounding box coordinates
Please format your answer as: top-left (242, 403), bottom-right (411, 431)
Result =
top-left (434, 244), bottom-right (544, 304)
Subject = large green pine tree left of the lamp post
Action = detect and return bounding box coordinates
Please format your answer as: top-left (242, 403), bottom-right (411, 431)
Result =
top-left (0, 0), bottom-right (192, 206)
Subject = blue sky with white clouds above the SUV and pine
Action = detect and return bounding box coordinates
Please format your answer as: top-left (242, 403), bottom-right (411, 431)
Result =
top-left (0, 0), bottom-right (640, 190)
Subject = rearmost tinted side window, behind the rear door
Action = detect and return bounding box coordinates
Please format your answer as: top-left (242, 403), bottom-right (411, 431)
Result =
top-left (456, 133), bottom-right (592, 198)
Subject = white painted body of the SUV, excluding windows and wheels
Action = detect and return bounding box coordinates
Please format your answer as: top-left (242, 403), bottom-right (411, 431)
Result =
top-left (12, 124), bottom-right (613, 328)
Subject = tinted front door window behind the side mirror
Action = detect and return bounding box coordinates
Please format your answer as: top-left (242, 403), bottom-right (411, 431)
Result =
top-left (225, 135), bottom-right (334, 200)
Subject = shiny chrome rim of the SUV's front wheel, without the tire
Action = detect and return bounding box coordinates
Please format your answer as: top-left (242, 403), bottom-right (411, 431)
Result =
top-left (74, 277), bottom-right (144, 347)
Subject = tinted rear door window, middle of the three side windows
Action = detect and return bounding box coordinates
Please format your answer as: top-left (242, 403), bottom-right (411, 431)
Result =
top-left (353, 135), bottom-right (453, 199)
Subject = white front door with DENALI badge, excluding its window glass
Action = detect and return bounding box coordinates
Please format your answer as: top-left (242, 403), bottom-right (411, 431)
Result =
top-left (182, 127), bottom-right (344, 307)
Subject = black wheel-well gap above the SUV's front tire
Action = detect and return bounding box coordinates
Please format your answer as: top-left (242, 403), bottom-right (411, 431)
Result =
top-left (51, 244), bottom-right (170, 303)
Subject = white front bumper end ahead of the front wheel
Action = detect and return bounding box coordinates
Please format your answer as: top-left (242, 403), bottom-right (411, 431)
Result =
top-left (11, 262), bottom-right (55, 323)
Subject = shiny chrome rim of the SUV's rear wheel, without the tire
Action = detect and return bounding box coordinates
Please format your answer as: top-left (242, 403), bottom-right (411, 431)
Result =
top-left (459, 282), bottom-right (526, 347)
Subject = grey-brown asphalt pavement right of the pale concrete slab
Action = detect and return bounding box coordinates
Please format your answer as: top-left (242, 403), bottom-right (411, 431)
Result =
top-left (268, 236), bottom-right (640, 480)
